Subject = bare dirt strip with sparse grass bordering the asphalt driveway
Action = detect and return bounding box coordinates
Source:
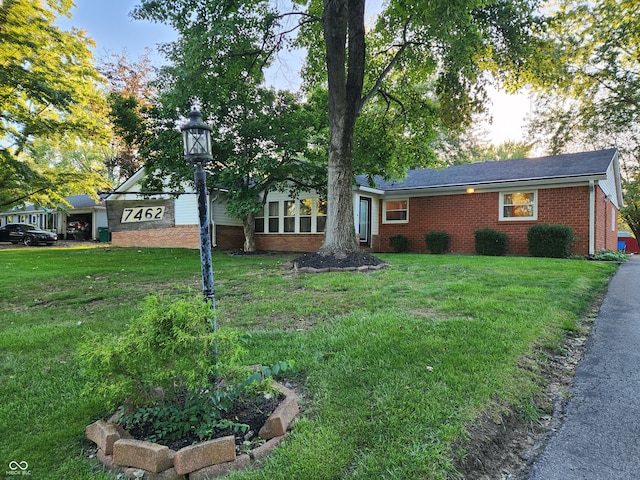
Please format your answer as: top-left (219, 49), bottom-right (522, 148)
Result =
top-left (456, 296), bottom-right (604, 480)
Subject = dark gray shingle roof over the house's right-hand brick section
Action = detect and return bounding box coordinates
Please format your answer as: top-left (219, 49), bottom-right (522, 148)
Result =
top-left (356, 148), bottom-right (617, 191)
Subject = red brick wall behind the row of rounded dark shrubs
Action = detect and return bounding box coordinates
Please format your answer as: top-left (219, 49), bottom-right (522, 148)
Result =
top-left (379, 186), bottom-right (610, 255)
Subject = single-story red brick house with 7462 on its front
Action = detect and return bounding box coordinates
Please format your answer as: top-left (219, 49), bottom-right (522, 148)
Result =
top-left (106, 149), bottom-right (623, 255)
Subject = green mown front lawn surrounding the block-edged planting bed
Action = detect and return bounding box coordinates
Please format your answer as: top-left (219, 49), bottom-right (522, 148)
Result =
top-left (0, 248), bottom-right (616, 480)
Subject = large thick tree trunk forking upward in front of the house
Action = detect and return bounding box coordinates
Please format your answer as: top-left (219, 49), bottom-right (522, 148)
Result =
top-left (319, 0), bottom-right (365, 255)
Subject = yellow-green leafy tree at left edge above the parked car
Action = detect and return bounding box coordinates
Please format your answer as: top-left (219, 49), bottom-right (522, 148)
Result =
top-left (0, 0), bottom-right (108, 207)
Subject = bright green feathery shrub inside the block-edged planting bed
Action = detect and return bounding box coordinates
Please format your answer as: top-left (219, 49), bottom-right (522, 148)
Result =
top-left (79, 295), bottom-right (248, 407)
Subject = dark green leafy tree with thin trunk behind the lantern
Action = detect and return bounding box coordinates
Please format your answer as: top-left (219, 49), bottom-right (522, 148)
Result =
top-left (135, 0), bottom-right (322, 251)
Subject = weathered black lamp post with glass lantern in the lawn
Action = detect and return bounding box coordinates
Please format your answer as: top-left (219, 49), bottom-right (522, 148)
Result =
top-left (180, 109), bottom-right (217, 332)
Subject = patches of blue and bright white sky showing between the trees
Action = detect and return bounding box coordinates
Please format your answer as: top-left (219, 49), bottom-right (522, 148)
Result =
top-left (58, 0), bottom-right (530, 145)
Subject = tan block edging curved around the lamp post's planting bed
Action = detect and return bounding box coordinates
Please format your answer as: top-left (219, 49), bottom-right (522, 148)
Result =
top-left (85, 384), bottom-right (300, 480)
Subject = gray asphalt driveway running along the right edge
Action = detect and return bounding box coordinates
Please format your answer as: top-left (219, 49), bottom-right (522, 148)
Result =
top-left (526, 255), bottom-right (640, 480)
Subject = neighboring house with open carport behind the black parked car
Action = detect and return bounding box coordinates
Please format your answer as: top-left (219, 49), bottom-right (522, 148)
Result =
top-left (0, 195), bottom-right (107, 240)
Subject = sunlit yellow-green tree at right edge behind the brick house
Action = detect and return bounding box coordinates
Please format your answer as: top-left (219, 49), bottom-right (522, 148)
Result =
top-left (530, 0), bottom-right (640, 238)
